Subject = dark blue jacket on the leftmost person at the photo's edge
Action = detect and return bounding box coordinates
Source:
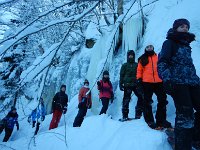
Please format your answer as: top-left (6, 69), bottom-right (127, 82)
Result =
top-left (3, 111), bottom-right (19, 129)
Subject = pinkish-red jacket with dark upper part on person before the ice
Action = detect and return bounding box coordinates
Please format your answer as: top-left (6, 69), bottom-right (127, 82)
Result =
top-left (97, 80), bottom-right (113, 99)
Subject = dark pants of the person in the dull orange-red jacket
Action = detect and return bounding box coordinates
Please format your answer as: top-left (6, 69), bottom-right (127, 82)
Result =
top-left (73, 106), bottom-right (87, 127)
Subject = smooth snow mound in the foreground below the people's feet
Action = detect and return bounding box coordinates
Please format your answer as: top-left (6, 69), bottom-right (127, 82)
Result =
top-left (1, 115), bottom-right (170, 150)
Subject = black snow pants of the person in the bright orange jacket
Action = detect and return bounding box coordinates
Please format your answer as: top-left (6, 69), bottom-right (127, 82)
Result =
top-left (143, 82), bottom-right (168, 124)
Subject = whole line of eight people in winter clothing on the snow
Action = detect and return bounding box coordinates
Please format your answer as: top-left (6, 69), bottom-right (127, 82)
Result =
top-left (0, 19), bottom-right (200, 150)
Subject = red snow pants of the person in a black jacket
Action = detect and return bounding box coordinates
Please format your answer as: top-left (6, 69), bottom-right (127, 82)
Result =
top-left (49, 110), bottom-right (62, 130)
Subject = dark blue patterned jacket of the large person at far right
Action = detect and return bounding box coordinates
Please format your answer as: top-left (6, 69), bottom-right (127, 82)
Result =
top-left (158, 31), bottom-right (200, 86)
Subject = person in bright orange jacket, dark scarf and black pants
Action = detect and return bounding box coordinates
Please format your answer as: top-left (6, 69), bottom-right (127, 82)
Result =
top-left (137, 45), bottom-right (171, 128)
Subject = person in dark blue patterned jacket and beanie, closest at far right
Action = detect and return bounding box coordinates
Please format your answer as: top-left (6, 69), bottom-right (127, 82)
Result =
top-left (158, 19), bottom-right (200, 150)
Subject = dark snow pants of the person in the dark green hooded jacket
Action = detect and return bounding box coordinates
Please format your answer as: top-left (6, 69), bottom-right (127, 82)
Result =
top-left (122, 87), bottom-right (143, 118)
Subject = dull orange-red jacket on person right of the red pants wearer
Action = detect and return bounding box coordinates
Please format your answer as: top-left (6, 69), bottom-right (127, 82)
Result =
top-left (78, 87), bottom-right (92, 106)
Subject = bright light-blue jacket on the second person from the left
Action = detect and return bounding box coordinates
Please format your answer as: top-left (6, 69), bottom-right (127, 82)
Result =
top-left (29, 105), bottom-right (46, 121)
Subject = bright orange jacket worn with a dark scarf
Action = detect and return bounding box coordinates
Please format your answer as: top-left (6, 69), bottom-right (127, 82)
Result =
top-left (137, 54), bottom-right (162, 83)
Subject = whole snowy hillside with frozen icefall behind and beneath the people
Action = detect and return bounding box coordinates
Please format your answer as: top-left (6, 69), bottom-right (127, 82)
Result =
top-left (0, 0), bottom-right (200, 150)
